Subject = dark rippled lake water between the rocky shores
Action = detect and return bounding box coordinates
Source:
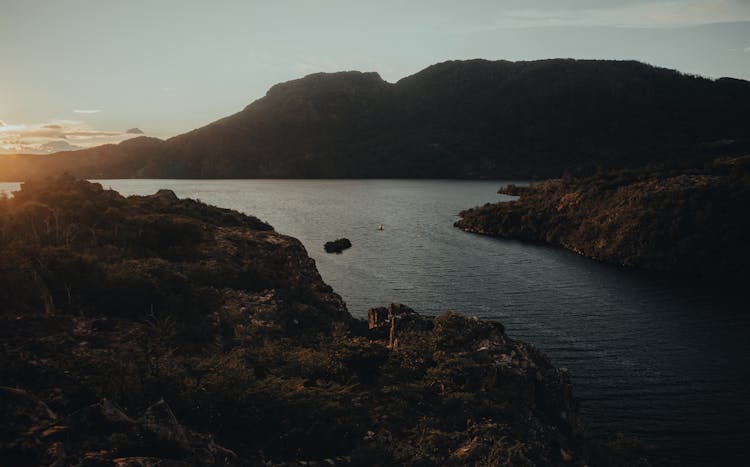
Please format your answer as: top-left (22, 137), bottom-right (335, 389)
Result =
top-left (0, 180), bottom-right (750, 465)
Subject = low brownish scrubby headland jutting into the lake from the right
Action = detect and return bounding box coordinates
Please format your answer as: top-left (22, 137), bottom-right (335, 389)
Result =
top-left (455, 156), bottom-right (750, 278)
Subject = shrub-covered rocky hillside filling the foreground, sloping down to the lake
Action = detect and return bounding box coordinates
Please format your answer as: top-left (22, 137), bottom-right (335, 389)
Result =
top-left (0, 177), bottom-right (646, 467)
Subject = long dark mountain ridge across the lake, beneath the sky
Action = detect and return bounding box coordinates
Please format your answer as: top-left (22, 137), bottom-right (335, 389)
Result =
top-left (0, 59), bottom-right (750, 180)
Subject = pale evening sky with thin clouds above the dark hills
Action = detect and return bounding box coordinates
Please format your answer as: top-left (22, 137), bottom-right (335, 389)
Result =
top-left (0, 0), bottom-right (750, 153)
